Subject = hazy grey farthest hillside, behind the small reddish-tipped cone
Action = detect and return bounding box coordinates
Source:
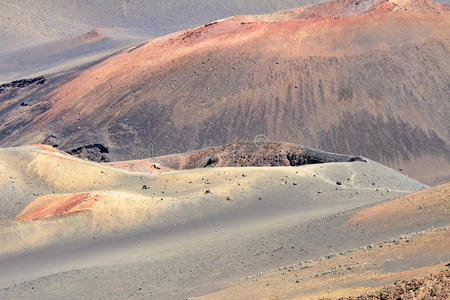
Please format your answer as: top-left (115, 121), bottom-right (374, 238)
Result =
top-left (0, 0), bottom-right (320, 52)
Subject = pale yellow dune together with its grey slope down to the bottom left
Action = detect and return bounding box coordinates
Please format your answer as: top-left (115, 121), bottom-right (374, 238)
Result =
top-left (0, 145), bottom-right (442, 299)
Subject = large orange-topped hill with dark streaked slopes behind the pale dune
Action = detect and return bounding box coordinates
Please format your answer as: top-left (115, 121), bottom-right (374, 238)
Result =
top-left (0, 0), bottom-right (450, 183)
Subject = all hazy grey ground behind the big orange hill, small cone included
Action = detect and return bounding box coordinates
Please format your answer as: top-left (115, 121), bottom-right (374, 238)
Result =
top-left (0, 0), bottom-right (326, 84)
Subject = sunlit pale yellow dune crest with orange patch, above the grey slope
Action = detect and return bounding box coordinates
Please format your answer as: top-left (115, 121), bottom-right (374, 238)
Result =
top-left (0, 145), bottom-right (423, 254)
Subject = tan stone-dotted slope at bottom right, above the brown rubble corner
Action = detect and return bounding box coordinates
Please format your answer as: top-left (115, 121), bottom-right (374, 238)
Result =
top-left (198, 230), bottom-right (450, 300)
